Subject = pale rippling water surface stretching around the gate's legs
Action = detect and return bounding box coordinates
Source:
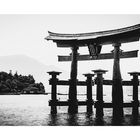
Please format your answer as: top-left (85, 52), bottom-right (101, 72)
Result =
top-left (0, 87), bottom-right (140, 126)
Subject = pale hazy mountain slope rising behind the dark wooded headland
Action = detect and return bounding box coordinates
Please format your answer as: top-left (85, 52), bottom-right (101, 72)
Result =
top-left (0, 55), bottom-right (69, 91)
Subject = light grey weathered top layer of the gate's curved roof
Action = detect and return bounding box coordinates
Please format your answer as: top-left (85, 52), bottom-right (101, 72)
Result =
top-left (45, 24), bottom-right (140, 40)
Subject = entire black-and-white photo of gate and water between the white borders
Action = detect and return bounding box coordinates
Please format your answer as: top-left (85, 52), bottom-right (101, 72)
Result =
top-left (0, 14), bottom-right (140, 126)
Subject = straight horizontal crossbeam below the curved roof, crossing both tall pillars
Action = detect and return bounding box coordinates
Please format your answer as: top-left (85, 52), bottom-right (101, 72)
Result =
top-left (58, 50), bottom-right (138, 62)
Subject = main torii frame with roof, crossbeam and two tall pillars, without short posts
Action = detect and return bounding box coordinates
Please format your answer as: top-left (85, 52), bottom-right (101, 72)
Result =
top-left (45, 24), bottom-right (140, 117)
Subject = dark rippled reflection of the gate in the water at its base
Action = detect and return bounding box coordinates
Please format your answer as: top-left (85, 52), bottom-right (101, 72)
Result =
top-left (47, 113), bottom-right (140, 126)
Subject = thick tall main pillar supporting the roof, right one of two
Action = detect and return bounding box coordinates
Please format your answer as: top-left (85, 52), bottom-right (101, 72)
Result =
top-left (112, 43), bottom-right (123, 118)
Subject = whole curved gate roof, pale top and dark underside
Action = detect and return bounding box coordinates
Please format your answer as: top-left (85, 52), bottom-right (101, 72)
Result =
top-left (45, 24), bottom-right (140, 47)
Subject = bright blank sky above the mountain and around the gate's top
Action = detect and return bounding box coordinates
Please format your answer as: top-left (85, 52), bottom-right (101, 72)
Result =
top-left (0, 14), bottom-right (140, 78)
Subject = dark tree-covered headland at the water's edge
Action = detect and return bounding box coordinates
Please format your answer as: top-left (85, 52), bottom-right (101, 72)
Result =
top-left (0, 71), bottom-right (45, 94)
